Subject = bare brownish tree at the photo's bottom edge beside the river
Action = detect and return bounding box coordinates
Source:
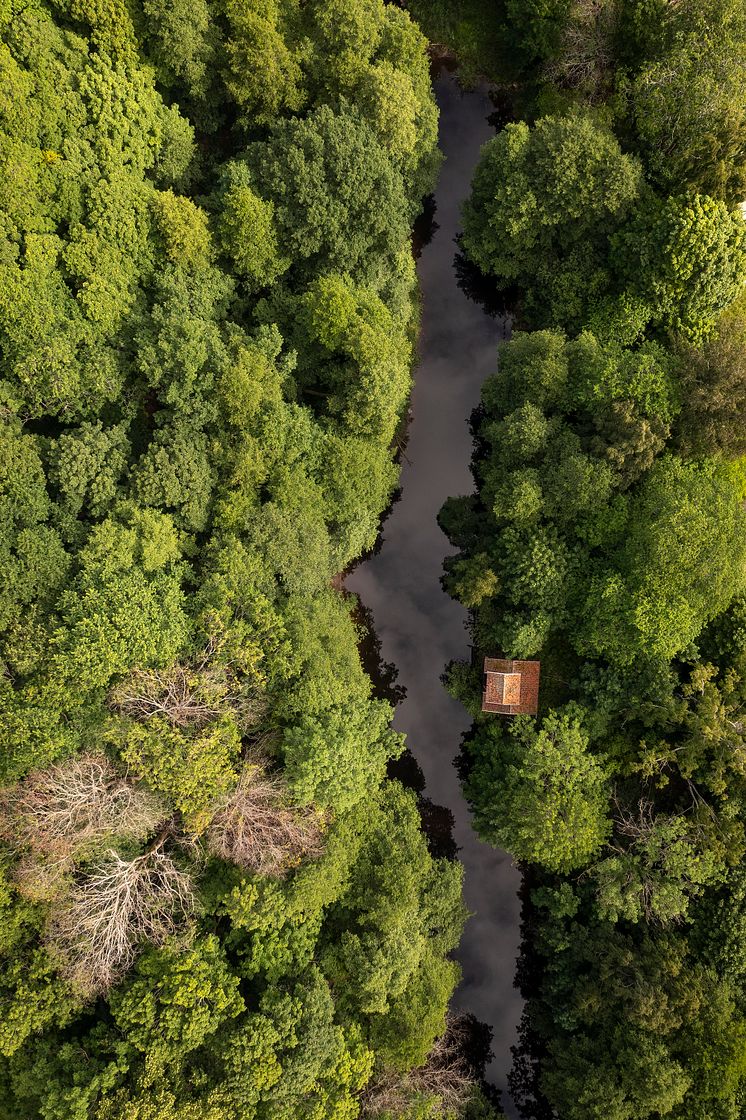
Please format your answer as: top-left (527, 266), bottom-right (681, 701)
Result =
top-left (363, 1015), bottom-right (476, 1117)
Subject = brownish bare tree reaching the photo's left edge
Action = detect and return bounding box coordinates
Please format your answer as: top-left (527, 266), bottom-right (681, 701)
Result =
top-left (0, 754), bottom-right (165, 860)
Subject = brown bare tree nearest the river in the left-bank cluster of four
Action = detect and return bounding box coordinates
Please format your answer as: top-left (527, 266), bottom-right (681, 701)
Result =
top-left (207, 760), bottom-right (323, 876)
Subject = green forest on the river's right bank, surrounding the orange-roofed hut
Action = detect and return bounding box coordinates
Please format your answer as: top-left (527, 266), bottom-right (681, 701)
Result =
top-left (421, 0), bottom-right (746, 1120)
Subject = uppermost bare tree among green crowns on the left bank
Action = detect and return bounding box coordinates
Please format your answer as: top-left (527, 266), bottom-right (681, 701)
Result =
top-left (109, 641), bottom-right (267, 730)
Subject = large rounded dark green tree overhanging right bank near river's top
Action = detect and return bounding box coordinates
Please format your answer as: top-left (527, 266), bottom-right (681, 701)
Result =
top-left (464, 114), bottom-right (642, 328)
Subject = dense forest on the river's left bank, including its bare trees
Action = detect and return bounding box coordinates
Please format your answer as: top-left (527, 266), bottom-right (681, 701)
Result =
top-left (0, 0), bottom-right (506, 1120)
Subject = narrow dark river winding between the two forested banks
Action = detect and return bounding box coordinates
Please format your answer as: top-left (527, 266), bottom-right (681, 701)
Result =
top-left (346, 73), bottom-right (521, 1117)
